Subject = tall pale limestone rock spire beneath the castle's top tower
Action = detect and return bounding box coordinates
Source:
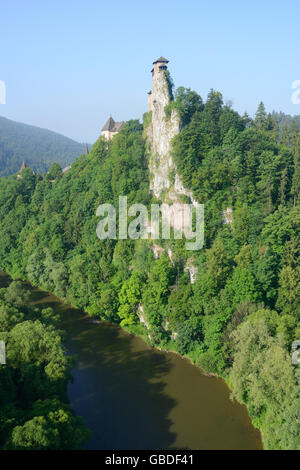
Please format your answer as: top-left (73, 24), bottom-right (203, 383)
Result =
top-left (146, 63), bottom-right (197, 290)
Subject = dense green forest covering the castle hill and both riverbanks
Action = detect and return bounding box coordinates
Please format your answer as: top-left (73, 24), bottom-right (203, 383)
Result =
top-left (0, 87), bottom-right (300, 449)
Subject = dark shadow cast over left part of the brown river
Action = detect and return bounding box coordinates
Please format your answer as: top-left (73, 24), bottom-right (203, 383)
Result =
top-left (30, 282), bottom-right (176, 450)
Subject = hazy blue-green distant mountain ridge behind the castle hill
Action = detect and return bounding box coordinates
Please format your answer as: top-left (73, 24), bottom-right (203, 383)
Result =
top-left (0, 117), bottom-right (86, 176)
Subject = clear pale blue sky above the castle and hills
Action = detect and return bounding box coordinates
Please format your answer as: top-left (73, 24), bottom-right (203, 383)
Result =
top-left (0, 0), bottom-right (300, 142)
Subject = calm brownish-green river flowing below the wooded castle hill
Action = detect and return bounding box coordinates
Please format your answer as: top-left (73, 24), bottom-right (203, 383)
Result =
top-left (1, 273), bottom-right (262, 450)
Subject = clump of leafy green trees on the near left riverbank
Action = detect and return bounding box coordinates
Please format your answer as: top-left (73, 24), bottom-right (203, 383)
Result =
top-left (0, 281), bottom-right (89, 450)
